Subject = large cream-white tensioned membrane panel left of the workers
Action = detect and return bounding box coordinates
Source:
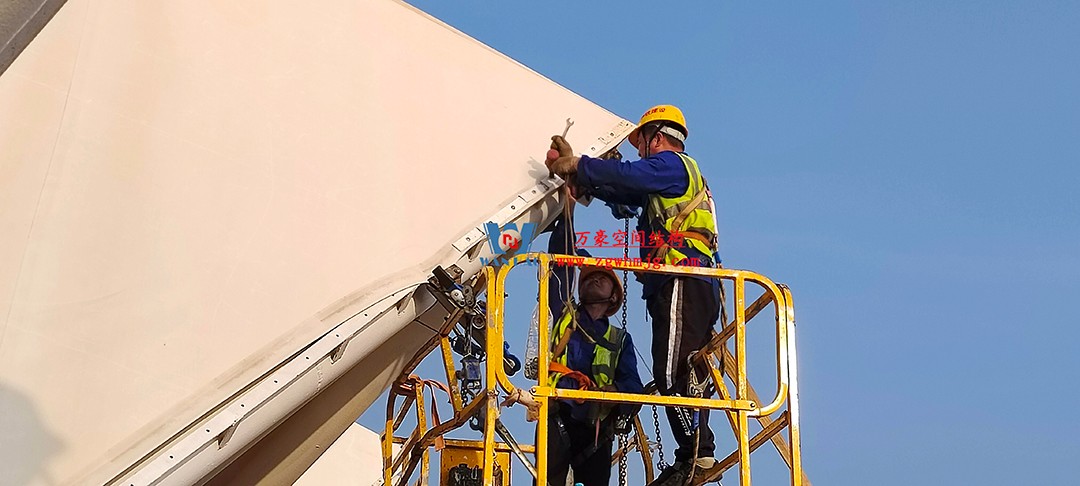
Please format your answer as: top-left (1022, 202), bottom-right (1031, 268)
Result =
top-left (0, 0), bottom-right (629, 485)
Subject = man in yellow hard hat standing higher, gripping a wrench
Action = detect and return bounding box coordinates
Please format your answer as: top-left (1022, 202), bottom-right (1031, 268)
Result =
top-left (546, 105), bottom-right (720, 485)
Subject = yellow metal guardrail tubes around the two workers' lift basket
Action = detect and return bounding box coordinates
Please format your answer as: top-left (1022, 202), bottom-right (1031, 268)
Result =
top-left (383, 253), bottom-right (810, 486)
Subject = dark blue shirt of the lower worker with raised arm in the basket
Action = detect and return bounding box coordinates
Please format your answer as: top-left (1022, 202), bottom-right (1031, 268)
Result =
top-left (548, 212), bottom-right (645, 422)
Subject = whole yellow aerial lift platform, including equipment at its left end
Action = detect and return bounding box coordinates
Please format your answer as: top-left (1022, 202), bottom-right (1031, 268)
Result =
top-left (382, 253), bottom-right (810, 486)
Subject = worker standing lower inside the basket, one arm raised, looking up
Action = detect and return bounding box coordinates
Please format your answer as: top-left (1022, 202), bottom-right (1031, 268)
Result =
top-left (548, 209), bottom-right (645, 486)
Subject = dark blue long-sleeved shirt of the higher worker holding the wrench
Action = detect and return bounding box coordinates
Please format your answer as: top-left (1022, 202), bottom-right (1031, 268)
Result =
top-left (577, 150), bottom-right (719, 299)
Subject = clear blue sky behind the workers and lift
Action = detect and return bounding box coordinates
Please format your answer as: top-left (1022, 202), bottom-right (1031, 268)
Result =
top-left (363, 0), bottom-right (1080, 486)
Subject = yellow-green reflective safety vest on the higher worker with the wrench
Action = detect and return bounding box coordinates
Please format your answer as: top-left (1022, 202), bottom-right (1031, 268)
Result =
top-left (648, 152), bottom-right (716, 265)
